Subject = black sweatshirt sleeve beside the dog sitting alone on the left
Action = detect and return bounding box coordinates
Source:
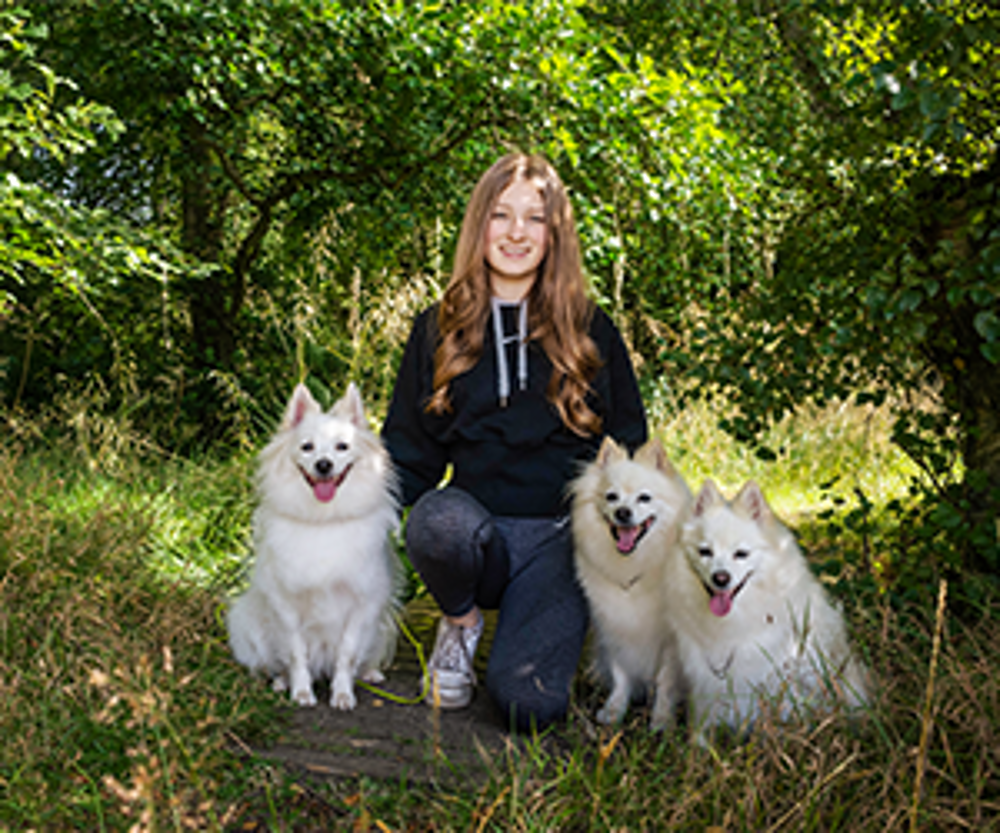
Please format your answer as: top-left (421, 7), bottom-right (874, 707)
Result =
top-left (382, 308), bottom-right (447, 506)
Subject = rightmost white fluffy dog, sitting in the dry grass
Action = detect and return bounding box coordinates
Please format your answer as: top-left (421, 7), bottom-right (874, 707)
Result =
top-left (662, 480), bottom-right (866, 741)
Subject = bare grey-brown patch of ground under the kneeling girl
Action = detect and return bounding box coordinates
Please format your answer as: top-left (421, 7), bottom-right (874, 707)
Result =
top-left (255, 601), bottom-right (544, 782)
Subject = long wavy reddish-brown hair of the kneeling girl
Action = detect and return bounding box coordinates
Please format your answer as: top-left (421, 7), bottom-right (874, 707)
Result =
top-left (427, 153), bottom-right (601, 436)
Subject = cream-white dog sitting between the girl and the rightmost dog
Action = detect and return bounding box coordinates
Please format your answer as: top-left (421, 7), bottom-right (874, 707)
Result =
top-left (571, 437), bottom-right (691, 728)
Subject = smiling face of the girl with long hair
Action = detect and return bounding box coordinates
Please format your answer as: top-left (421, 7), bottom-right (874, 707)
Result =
top-left (484, 178), bottom-right (549, 301)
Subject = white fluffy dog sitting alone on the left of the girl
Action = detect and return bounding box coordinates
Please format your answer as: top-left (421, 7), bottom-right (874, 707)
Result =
top-left (228, 383), bottom-right (400, 709)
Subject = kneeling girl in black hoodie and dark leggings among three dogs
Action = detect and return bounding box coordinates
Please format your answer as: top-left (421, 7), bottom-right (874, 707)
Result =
top-left (382, 154), bottom-right (647, 731)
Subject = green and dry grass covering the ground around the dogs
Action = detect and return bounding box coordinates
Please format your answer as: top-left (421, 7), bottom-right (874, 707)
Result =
top-left (0, 400), bottom-right (1000, 831)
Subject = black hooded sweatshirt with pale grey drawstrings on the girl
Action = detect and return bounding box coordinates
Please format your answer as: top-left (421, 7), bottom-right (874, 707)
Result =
top-left (382, 305), bottom-right (647, 517)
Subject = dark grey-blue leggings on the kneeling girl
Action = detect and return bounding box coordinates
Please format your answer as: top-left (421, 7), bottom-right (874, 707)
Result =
top-left (406, 486), bottom-right (587, 732)
